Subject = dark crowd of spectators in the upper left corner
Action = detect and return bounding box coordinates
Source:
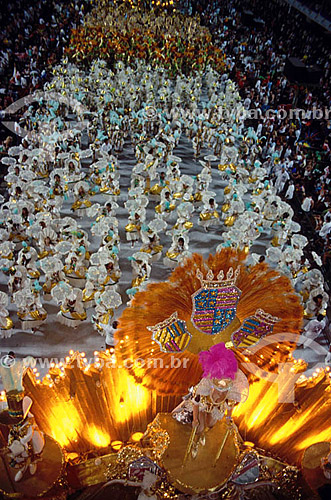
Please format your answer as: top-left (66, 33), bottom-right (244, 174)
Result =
top-left (0, 0), bottom-right (90, 150)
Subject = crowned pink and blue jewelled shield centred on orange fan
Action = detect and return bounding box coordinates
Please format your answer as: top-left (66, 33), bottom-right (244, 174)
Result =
top-left (191, 267), bottom-right (241, 335)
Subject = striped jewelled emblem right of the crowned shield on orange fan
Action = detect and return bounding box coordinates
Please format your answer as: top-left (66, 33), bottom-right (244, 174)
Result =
top-left (231, 309), bottom-right (280, 349)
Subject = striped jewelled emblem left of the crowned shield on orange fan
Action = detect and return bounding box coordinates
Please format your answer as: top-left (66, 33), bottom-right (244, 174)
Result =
top-left (147, 312), bottom-right (192, 353)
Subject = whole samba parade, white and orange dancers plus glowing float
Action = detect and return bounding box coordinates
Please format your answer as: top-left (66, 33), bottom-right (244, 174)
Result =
top-left (0, 1), bottom-right (331, 500)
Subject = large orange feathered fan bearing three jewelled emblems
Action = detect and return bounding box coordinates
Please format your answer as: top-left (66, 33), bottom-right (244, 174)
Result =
top-left (116, 249), bottom-right (302, 395)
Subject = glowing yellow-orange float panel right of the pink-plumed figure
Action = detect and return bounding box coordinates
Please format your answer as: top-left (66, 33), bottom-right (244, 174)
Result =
top-left (233, 364), bottom-right (331, 463)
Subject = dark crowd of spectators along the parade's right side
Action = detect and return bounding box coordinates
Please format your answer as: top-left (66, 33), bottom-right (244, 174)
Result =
top-left (194, 0), bottom-right (331, 278)
